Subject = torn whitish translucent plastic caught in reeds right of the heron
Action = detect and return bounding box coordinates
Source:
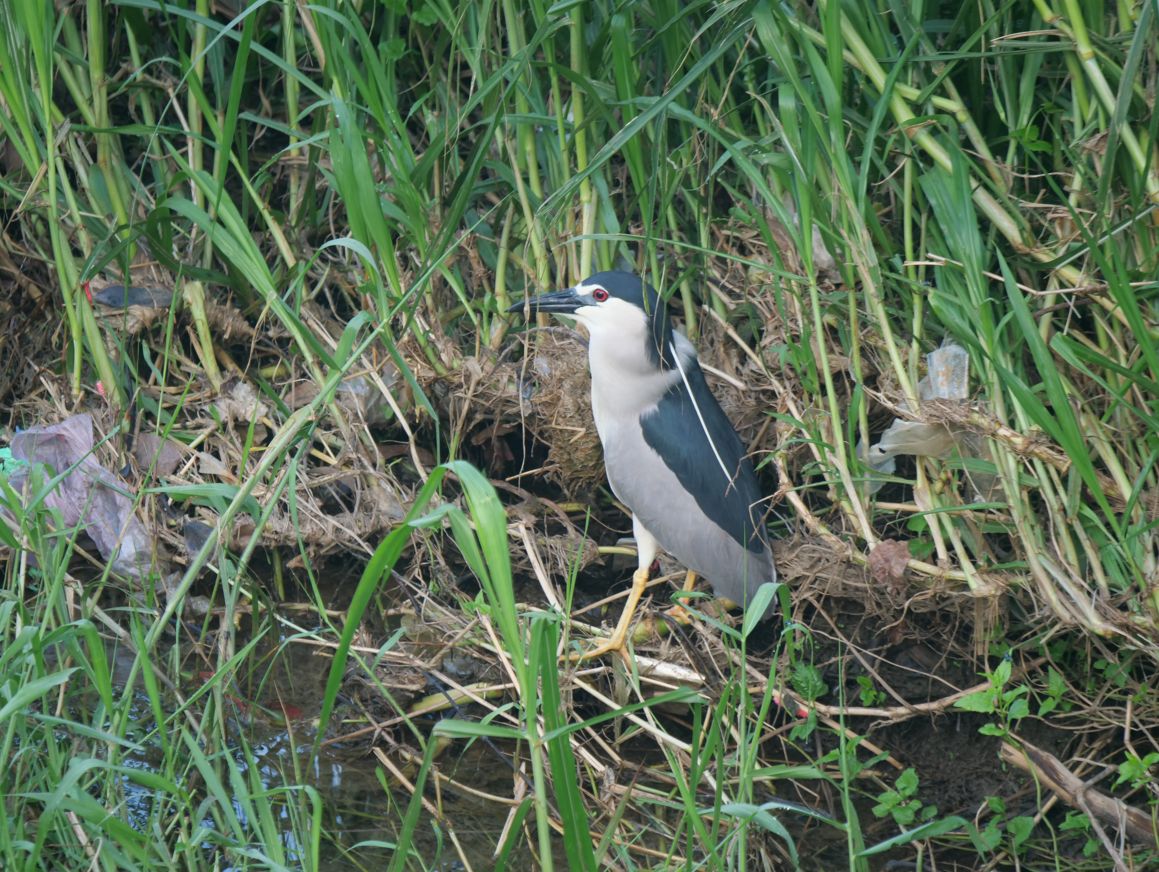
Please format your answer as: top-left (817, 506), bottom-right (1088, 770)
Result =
top-left (857, 339), bottom-right (997, 502)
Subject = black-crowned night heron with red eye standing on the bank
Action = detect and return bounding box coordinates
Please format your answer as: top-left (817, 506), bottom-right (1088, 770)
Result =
top-left (508, 271), bottom-right (777, 656)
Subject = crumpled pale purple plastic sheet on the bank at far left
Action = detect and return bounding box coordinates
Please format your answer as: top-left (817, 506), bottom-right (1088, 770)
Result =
top-left (9, 415), bottom-right (153, 579)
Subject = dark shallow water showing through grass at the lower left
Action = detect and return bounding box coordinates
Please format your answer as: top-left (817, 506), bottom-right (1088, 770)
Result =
top-left (109, 565), bottom-right (542, 872)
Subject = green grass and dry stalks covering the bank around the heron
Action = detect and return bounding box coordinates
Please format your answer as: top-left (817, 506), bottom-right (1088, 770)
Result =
top-left (0, 0), bottom-right (1159, 870)
